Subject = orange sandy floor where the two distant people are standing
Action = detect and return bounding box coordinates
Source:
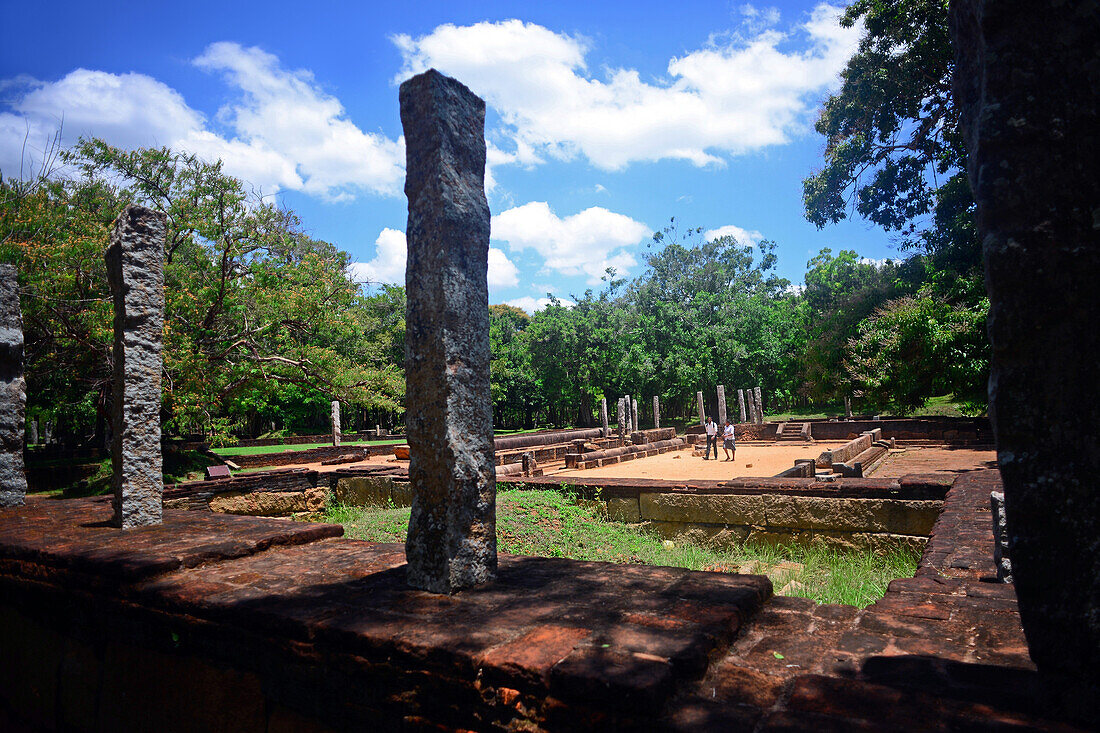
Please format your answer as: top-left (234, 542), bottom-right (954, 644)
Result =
top-left (554, 440), bottom-right (846, 481)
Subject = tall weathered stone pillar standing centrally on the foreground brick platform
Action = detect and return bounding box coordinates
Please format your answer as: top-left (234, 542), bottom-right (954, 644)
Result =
top-left (400, 69), bottom-right (496, 593)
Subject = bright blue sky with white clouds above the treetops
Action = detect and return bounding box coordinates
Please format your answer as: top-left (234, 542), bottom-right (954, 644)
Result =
top-left (0, 0), bottom-right (898, 310)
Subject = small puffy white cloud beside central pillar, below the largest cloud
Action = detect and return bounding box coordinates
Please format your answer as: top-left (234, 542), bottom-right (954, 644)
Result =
top-left (492, 201), bottom-right (651, 284)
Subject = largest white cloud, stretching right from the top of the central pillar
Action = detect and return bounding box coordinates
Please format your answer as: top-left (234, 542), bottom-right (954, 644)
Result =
top-left (393, 3), bottom-right (861, 169)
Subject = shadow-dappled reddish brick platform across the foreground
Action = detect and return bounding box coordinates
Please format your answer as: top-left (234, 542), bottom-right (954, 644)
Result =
top-left (0, 471), bottom-right (1088, 731)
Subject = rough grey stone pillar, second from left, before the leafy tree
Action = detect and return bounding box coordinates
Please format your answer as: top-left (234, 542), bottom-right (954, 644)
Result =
top-left (105, 205), bottom-right (167, 529)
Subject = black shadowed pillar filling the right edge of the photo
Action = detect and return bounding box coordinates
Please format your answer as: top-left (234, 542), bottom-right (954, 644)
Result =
top-left (950, 0), bottom-right (1100, 686)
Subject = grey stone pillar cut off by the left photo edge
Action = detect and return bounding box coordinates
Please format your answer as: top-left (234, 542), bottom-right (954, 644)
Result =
top-left (0, 264), bottom-right (26, 506)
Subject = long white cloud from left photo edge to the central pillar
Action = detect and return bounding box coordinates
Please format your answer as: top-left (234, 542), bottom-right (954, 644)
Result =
top-left (0, 43), bottom-right (405, 198)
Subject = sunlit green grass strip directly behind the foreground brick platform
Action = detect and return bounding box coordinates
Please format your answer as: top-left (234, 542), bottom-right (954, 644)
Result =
top-left (325, 490), bottom-right (917, 608)
